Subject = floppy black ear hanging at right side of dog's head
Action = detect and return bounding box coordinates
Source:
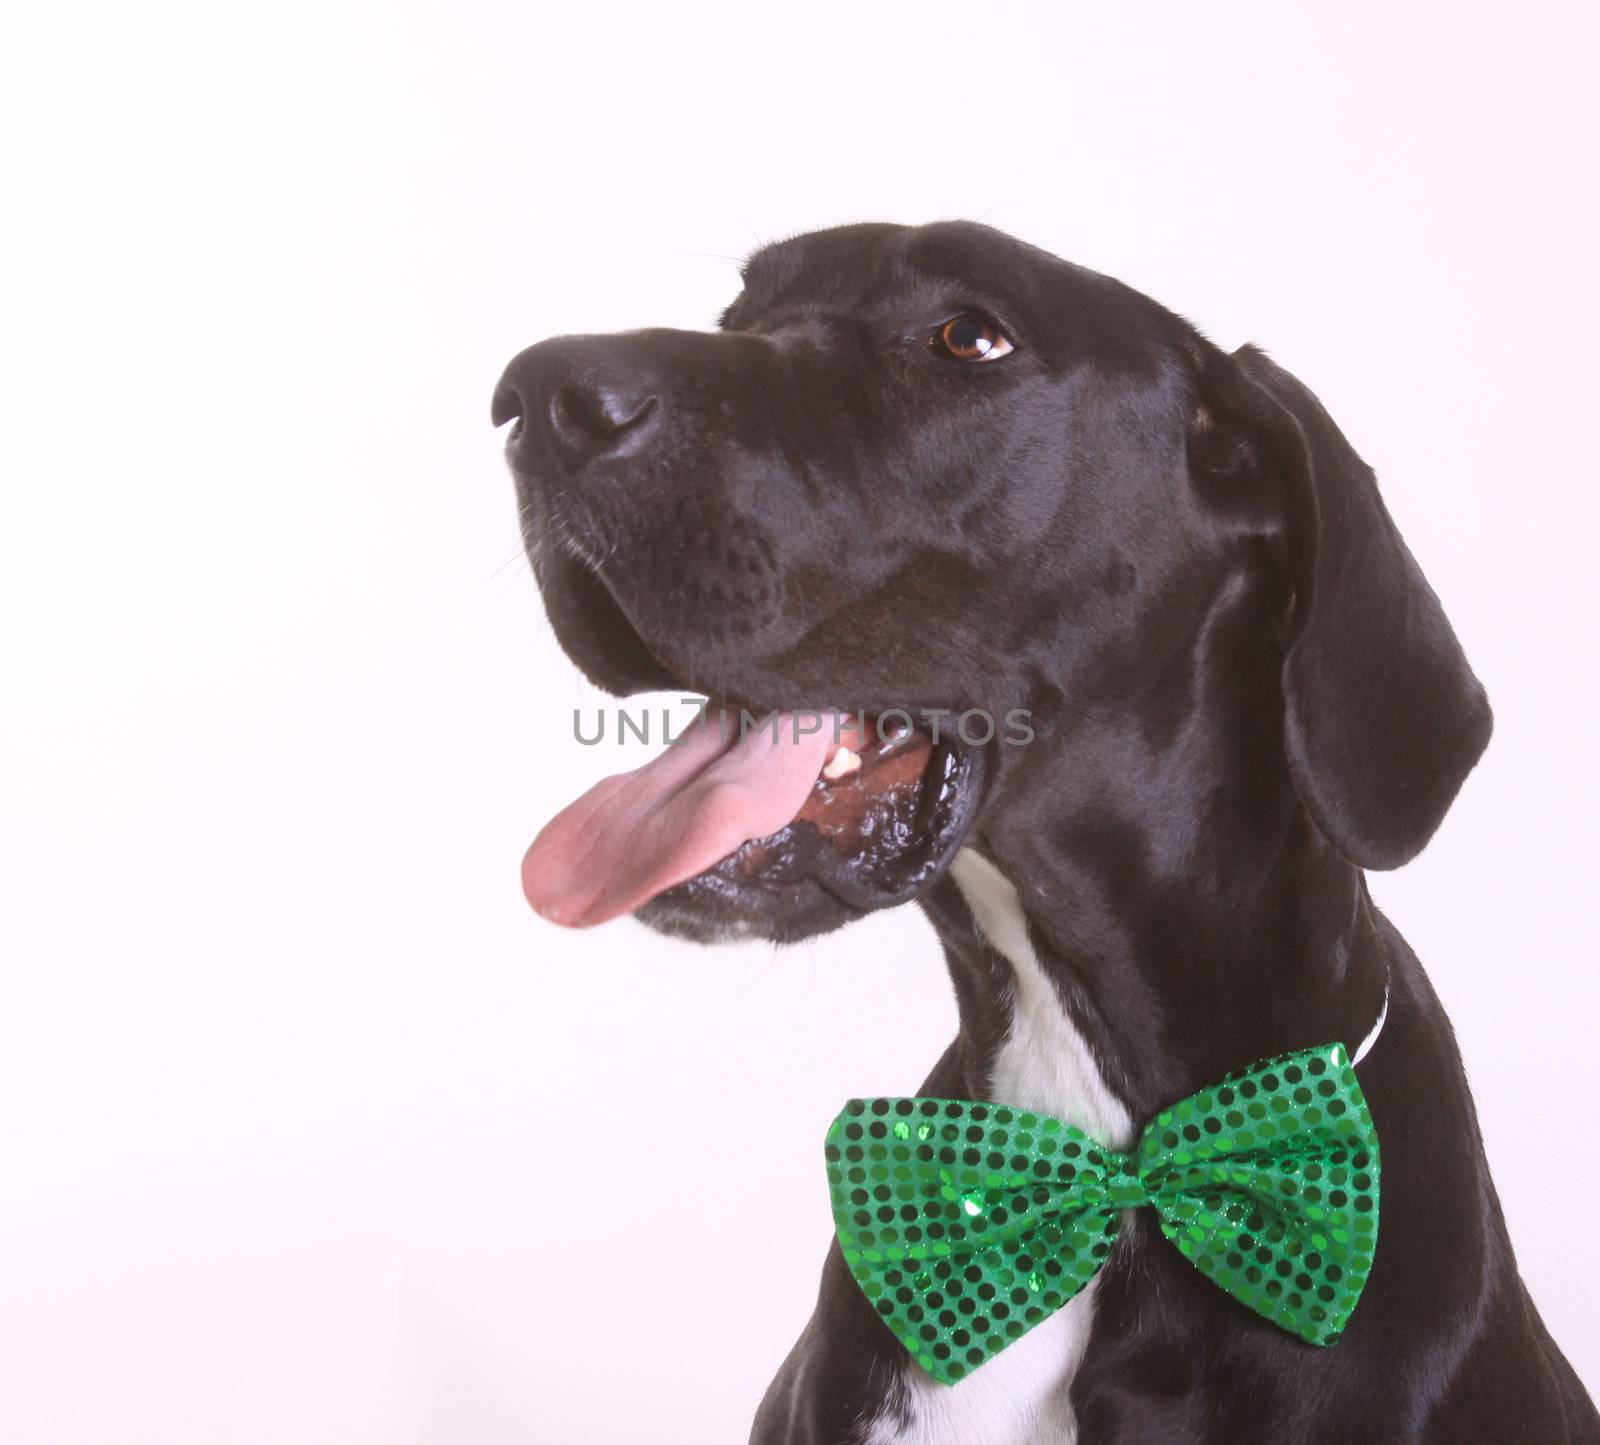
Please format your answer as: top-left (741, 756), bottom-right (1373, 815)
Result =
top-left (1190, 346), bottom-right (1493, 869)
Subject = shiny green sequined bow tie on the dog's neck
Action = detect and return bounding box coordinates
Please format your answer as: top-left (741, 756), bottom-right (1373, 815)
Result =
top-left (827, 1043), bottom-right (1378, 1384)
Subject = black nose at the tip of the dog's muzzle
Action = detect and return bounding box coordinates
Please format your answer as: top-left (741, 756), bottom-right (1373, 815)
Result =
top-left (491, 342), bottom-right (661, 466)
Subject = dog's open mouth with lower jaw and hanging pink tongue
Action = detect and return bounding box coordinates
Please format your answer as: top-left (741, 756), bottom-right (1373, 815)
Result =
top-left (523, 707), bottom-right (981, 938)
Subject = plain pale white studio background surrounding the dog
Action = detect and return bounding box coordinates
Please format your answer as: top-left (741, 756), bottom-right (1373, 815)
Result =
top-left (9, 0), bottom-right (1600, 1445)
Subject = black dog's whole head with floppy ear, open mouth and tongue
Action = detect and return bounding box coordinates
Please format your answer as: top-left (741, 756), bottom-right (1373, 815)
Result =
top-left (493, 222), bottom-right (1490, 939)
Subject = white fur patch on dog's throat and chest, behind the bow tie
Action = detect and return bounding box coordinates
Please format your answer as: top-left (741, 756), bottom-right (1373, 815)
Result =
top-left (862, 848), bottom-right (1134, 1445)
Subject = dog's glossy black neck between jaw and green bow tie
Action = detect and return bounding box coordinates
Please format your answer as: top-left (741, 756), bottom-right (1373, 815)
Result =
top-left (926, 566), bottom-right (1389, 1120)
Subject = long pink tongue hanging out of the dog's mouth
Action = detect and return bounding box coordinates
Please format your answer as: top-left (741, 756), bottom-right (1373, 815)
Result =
top-left (522, 710), bottom-right (834, 928)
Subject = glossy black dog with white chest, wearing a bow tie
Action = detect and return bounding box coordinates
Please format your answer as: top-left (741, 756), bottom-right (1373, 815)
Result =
top-left (494, 224), bottom-right (1600, 1445)
